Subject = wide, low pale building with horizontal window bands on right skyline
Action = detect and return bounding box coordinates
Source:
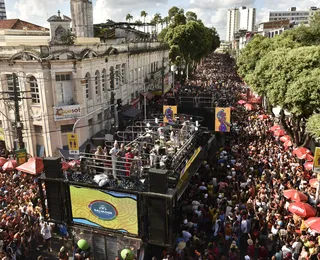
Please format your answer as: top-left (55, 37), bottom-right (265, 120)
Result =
top-left (269, 7), bottom-right (319, 24)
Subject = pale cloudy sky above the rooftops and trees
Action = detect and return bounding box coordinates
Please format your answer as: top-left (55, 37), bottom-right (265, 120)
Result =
top-left (5, 0), bottom-right (320, 40)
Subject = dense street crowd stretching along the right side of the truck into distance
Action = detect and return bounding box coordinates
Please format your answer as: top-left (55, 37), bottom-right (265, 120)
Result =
top-left (165, 54), bottom-right (320, 260)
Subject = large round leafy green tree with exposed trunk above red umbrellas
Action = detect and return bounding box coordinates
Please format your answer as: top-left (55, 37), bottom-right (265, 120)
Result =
top-left (249, 46), bottom-right (320, 145)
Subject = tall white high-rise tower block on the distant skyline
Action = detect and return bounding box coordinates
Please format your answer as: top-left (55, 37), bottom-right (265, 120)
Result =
top-left (226, 6), bottom-right (256, 41)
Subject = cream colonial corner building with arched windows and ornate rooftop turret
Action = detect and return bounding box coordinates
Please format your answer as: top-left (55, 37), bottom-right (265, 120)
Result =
top-left (0, 0), bottom-right (168, 156)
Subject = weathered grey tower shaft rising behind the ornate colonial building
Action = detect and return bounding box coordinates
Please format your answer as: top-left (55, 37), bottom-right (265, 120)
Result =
top-left (70, 0), bottom-right (93, 38)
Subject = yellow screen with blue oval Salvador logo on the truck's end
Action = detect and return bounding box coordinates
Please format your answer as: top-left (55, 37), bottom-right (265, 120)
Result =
top-left (70, 186), bottom-right (139, 235)
